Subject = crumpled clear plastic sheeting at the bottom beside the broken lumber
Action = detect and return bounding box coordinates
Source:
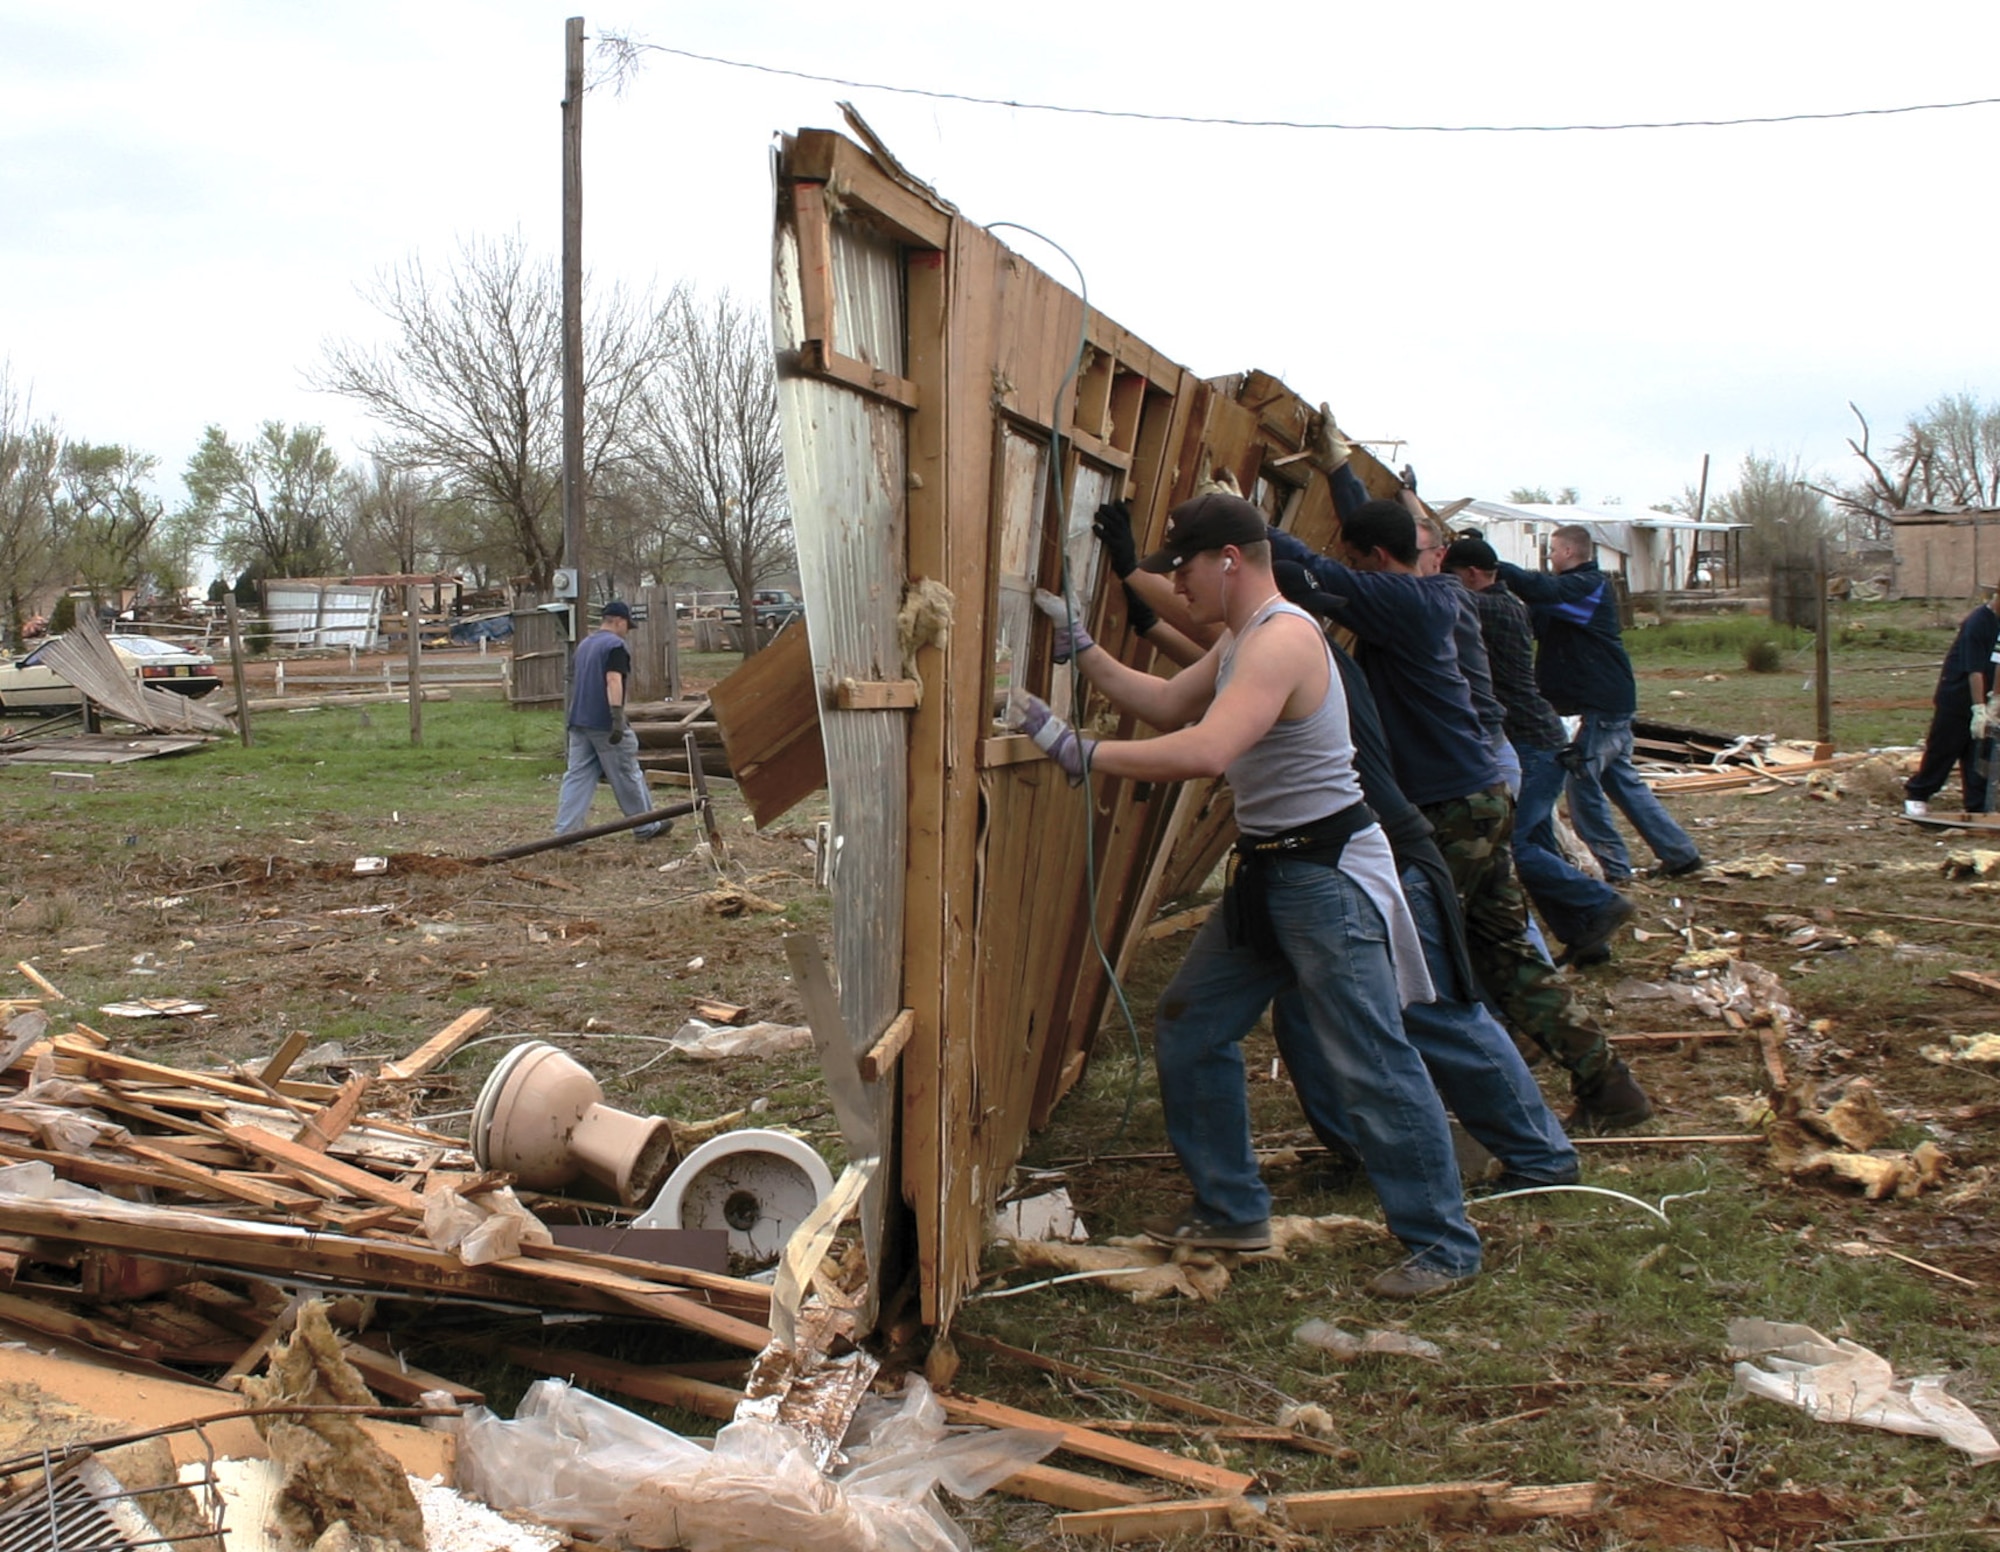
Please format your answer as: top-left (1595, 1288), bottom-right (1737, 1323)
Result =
top-left (458, 1374), bottom-right (1060, 1552)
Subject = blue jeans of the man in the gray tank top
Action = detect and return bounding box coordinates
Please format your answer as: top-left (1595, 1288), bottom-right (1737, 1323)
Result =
top-left (1154, 860), bottom-right (1480, 1276)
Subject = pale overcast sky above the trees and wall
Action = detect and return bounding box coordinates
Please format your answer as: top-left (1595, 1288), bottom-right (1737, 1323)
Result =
top-left (0, 0), bottom-right (2000, 520)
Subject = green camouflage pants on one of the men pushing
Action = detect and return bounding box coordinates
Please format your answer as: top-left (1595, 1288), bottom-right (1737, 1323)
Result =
top-left (1424, 786), bottom-right (1612, 1088)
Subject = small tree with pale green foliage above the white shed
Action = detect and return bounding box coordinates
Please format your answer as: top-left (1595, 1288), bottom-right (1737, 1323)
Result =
top-left (182, 420), bottom-right (340, 576)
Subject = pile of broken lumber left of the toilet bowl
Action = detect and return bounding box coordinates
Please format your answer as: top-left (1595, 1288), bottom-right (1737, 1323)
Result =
top-left (0, 1010), bottom-right (770, 1400)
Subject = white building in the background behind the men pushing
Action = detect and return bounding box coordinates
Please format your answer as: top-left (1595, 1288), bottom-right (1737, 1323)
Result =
top-left (1444, 502), bottom-right (1744, 596)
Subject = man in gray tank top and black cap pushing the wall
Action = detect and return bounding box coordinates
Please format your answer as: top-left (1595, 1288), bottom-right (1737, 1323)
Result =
top-left (1016, 492), bottom-right (1480, 1298)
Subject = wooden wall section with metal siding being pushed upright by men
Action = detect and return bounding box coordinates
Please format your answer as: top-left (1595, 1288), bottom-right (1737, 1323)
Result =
top-left (772, 130), bottom-right (1394, 1324)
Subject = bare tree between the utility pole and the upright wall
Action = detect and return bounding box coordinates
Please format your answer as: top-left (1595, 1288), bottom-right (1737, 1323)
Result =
top-left (634, 292), bottom-right (792, 652)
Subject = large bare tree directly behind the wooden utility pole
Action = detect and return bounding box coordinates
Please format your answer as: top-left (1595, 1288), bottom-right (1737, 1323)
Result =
top-left (314, 236), bottom-right (672, 586)
